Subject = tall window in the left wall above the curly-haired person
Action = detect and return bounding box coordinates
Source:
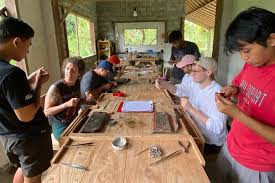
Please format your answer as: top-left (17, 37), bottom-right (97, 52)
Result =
top-left (66, 13), bottom-right (96, 57)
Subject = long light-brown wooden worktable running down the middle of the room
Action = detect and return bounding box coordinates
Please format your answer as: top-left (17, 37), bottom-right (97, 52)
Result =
top-left (43, 67), bottom-right (209, 183)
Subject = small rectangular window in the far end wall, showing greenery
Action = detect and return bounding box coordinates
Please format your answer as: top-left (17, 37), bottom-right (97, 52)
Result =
top-left (124, 28), bottom-right (157, 46)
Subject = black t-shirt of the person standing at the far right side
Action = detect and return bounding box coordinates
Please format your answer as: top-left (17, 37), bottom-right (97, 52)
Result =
top-left (171, 41), bottom-right (200, 81)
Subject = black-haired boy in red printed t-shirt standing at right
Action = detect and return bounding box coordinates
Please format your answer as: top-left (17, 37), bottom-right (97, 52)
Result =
top-left (215, 7), bottom-right (275, 183)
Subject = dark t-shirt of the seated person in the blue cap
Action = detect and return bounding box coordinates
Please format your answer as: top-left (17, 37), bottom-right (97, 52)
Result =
top-left (80, 71), bottom-right (108, 98)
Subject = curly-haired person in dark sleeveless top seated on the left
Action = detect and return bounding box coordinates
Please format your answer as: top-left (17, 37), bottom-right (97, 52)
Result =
top-left (44, 57), bottom-right (85, 140)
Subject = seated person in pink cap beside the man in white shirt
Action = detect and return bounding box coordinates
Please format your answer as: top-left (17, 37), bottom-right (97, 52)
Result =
top-left (155, 55), bottom-right (195, 96)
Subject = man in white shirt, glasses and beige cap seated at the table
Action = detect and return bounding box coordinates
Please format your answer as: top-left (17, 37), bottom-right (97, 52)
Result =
top-left (180, 57), bottom-right (227, 150)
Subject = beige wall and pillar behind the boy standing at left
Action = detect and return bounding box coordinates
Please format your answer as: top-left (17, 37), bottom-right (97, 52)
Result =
top-left (18, 0), bottom-right (60, 93)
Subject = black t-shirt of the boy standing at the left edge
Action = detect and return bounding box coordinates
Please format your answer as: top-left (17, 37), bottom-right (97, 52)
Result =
top-left (0, 60), bottom-right (50, 136)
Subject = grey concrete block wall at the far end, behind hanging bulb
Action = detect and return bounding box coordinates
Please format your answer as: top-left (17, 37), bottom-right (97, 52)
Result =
top-left (96, 0), bottom-right (184, 40)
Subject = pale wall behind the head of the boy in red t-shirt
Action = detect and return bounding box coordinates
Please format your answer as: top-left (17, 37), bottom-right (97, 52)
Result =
top-left (218, 0), bottom-right (275, 85)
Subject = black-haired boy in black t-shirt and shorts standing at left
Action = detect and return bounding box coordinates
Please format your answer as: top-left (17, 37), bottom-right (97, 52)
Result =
top-left (0, 17), bottom-right (53, 183)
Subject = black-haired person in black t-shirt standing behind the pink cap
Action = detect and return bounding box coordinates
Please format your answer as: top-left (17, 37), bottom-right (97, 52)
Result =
top-left (169, 31), bottom-right (200, 84)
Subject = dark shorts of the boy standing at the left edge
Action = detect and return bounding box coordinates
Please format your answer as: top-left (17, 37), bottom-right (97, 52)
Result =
top-left (0, 133), bottom-right (53, 177)
